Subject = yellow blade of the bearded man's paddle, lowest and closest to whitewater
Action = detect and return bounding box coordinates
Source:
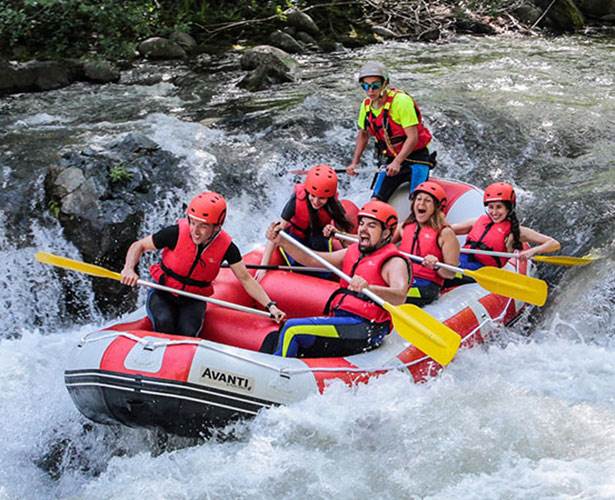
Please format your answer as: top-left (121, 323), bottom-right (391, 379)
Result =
top-left (383, 302), bottom-right (461, 366)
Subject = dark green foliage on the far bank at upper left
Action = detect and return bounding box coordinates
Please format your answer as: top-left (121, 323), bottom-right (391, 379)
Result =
top-left (0, 0), bottom-right (300, 59)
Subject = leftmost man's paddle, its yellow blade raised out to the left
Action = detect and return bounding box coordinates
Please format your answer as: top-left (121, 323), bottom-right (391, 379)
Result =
top-left (34, 252), bottom-right (273, 318)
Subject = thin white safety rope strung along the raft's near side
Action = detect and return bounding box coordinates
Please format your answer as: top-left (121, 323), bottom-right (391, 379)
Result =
top-left (79, 299), bottom-right (513, 376)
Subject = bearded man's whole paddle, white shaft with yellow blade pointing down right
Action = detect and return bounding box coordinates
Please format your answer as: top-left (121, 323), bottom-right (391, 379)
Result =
top-left (280, 231), bottom-right (461, 366)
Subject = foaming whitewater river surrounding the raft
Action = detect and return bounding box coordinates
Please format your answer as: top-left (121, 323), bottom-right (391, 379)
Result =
top-left (0, 36), bottom-right (615, 500)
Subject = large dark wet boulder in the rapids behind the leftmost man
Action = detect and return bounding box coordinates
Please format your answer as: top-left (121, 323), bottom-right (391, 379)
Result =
top-left (45, 134), bottom-right (188, 312)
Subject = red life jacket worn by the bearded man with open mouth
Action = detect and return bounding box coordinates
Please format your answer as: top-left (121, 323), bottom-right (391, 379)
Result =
top-left (329, 243), bottom-right (410, 323)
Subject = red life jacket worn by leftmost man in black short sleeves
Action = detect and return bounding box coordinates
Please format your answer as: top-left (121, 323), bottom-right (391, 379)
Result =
top-left (149, 219), bottom-right (232, 296)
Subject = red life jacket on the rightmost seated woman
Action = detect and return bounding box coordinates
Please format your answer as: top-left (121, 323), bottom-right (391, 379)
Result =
top-left (463, 215), bottom-right (512, 267)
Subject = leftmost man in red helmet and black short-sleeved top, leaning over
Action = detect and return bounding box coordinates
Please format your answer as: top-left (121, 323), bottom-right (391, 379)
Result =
top-left (121, 192), bottom-right (285, 337)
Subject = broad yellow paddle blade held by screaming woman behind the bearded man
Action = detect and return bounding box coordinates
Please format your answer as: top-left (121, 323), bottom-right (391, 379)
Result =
top-left (464, 266), bottom-right (548, 306)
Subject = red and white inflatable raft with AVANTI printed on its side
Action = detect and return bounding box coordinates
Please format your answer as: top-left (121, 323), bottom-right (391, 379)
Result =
top-left (65, 180), bottom-right (532, 435)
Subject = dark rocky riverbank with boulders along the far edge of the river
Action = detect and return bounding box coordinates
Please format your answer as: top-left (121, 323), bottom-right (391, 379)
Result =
top-left (0, 0), bottom-right (615, 95)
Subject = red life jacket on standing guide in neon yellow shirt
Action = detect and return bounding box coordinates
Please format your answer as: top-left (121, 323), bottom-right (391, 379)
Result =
top-left (363, 88), bottom-right (431, 158)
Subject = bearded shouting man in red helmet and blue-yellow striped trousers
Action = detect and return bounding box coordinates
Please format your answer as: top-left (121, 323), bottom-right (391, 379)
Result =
top-left (267, 201), bottom-right (410, 357)
